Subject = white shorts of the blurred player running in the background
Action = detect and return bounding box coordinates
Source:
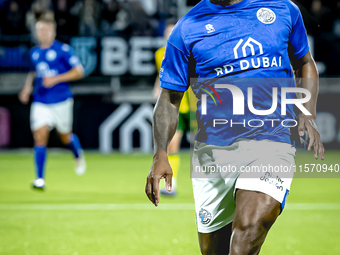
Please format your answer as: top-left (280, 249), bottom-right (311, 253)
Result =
top-left (30, 98), bottom-right (73, 134)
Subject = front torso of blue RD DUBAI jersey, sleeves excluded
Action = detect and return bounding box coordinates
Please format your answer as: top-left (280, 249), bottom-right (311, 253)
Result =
top-left (178, 0), bottom-right (295, 146)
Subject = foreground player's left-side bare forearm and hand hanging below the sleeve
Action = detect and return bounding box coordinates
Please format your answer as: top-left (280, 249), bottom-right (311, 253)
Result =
top-left (145, 88), bottom-right (184, 206)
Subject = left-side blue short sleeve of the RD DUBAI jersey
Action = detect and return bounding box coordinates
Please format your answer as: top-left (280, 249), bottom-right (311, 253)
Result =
top-left (159, 23), bottom-right (190, 92)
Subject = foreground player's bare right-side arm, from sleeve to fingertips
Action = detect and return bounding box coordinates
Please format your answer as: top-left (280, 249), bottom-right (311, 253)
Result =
top-left (292, 52), bottom-right (325, 160)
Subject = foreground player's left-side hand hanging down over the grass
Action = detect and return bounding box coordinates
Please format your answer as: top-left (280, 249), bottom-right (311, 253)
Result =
top-left (145, 151), bottom-right (172, 206)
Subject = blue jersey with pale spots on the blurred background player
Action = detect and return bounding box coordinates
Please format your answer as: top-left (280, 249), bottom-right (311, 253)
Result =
top-left (30, 41), bottom-right (80, 104)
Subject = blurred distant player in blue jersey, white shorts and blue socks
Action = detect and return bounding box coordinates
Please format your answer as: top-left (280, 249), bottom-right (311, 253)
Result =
top-left (19, 18), bottom-right (86, 190)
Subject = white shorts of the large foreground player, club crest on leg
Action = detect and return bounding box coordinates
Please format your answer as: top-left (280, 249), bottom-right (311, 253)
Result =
top-left (192, 140), bottom-right (296, 233)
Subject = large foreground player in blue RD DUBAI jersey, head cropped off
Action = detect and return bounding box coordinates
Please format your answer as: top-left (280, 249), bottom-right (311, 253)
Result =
top-left (145, 0), bottom-right (324, 255)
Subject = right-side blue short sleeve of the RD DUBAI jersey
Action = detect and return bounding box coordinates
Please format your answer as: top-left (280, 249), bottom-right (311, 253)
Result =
top-left (288, 2), bottom-right (309, 59)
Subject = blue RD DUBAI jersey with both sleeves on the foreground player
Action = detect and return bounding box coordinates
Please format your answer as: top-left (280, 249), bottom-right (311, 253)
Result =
top-left (160, 0), bottom-right (309, 146)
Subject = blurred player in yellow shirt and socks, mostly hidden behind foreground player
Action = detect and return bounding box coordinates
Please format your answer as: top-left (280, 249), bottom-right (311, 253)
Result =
top-left (154, 21), bottom-right (190, 196)
